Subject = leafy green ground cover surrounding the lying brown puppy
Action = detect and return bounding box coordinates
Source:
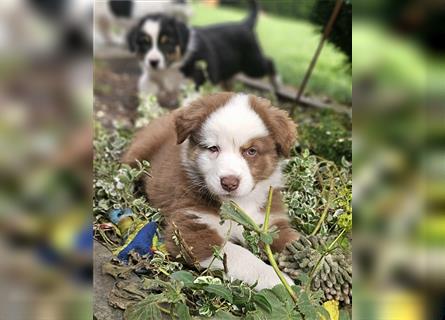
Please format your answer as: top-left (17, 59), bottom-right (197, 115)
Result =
top-left (93, 87), bottom-right (352, 320)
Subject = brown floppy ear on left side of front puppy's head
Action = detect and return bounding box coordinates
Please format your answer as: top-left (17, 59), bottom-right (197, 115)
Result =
top-left (175, 92), bottom-right (233, 144)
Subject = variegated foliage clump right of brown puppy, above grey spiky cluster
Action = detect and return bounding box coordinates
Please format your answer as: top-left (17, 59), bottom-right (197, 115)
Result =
top-left (283, 150), bottom-right (352, 234)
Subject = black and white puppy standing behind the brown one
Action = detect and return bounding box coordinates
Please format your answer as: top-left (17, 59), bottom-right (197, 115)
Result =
top-left (128, 1), bottom-right (278, 92)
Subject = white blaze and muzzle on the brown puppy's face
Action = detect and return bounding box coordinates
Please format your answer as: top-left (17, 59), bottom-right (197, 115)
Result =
top-left (197, 94), bottom-right (269, 196)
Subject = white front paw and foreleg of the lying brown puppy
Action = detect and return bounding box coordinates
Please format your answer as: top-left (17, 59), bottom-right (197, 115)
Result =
top-left (200, 242), bottom-right (293, 290)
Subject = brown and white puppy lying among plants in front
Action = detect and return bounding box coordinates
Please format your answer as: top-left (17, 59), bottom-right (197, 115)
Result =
top-left (123, 93), bottom-right (298, 289)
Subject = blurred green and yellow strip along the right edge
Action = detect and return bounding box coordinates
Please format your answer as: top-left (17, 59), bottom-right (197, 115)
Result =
top-left (352, 1), bottom-right (445, 319)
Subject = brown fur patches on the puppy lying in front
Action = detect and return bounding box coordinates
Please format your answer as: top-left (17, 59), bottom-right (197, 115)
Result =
top-left (122, 93), bottom-right (298, 260)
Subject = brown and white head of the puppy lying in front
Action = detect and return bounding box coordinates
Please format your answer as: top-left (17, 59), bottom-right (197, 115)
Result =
top-left (176, 94), bottom-right (296, 199)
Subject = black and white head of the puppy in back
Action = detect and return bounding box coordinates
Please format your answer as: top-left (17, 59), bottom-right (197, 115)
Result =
top-left (127, 15), bottom-right (189, 70)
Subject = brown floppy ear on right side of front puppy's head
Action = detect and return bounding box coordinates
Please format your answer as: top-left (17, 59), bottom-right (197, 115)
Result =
top-left (249, 96), bottom-right (297, 158)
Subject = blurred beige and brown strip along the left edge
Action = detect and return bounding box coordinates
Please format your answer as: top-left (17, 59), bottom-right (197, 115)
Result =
top-left (0, 0), bottom-right (93, 319)
